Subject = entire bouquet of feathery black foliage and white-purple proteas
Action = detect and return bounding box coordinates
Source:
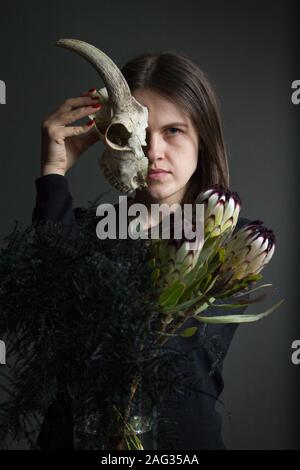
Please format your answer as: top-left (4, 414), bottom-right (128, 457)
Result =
top-left (0, 187), bottom-right (282, 449)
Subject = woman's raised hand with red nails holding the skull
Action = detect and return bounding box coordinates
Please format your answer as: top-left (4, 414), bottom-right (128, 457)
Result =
top-left (41, 89), bottom-right (101, 176)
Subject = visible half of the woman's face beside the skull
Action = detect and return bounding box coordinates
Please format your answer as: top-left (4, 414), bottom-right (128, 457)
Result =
top-left (132, 88), bottom-right (199, 205)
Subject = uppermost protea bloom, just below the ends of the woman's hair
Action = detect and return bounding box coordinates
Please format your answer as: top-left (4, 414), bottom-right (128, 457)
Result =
top-left (195, 185), bottom-right (242, 237)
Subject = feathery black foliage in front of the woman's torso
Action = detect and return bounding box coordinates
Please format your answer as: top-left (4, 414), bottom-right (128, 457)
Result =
top-left (0, 201), bottom-right (218, 448)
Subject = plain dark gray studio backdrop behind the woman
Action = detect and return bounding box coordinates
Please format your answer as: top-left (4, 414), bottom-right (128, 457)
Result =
top-left (0, 0), bottom-right (300, 449)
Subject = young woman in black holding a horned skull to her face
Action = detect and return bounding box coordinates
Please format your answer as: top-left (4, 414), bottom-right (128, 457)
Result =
top-left (33, 52), bottom-right (247, 449)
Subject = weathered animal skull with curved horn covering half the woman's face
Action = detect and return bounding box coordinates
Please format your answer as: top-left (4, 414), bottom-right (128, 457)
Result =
top-left (56, 39), bottom-right (148, 194)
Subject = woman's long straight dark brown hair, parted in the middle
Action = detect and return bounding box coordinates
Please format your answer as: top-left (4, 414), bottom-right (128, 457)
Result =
top-left (121, 52), bottom-right (229, 204)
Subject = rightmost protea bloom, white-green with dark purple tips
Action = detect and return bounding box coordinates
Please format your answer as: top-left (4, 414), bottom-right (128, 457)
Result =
top-left (220, 220), bottom-right (275, 282)
